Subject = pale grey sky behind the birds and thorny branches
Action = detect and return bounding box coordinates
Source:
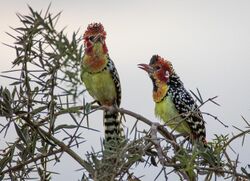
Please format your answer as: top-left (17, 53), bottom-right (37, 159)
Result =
top-left (0, 0), bottom-right (250, 180)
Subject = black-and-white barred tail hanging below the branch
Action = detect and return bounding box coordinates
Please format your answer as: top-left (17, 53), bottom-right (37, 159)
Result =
top-left (104, 111), bottom-right (124, 143)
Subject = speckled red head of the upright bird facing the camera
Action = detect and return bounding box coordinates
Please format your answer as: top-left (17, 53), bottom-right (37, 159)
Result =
top-left (83, 23), bottom-right (108, 53)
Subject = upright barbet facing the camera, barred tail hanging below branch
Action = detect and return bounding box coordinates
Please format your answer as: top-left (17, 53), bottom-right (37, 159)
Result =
top-left (81, 23), bottom-right (123, 142)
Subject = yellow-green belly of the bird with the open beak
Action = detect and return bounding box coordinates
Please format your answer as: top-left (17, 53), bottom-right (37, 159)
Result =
top-left (155, 96), bottom-right (191, 135)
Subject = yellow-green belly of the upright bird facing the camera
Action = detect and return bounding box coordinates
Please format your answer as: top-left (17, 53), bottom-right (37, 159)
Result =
top-left (82, 70), bottom-right (117, 105)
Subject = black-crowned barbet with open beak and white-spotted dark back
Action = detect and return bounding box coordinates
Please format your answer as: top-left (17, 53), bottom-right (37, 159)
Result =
top-left (138, 55), bottom-right (206, 145)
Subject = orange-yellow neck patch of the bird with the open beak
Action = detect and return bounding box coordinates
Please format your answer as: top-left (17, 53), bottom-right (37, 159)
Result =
top-left (153, 80), bottom-right (169, 103)
